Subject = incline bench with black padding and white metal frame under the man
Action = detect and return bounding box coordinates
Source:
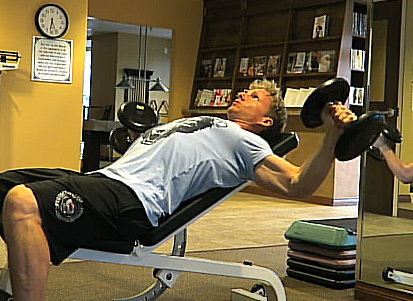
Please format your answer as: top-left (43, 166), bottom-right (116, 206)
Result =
top-left (0, 132), bottom-right (298, 301)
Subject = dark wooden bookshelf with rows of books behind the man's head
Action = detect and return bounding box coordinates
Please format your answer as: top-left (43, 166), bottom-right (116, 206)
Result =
top-left (188, 0), bottom-right (370, 114)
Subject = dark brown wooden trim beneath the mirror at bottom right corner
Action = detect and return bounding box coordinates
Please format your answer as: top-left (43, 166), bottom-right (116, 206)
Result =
top-left (354, 281), bottom-right (413, 301)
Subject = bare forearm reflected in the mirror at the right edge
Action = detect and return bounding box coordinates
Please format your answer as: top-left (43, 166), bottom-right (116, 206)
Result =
top-left (374, 135), bottom-right (413, 183)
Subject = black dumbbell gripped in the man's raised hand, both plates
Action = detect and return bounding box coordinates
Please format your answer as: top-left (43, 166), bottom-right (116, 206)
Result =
top-left (300, 77), bottom-right (400, 161)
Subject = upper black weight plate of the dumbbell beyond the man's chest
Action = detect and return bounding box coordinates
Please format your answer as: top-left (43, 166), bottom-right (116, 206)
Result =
top-left (118, 102), bottom-right (158, 133)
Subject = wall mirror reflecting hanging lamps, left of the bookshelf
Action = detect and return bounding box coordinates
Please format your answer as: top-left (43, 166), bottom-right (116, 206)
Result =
top-left (85, 17), bottom-right (172, 122)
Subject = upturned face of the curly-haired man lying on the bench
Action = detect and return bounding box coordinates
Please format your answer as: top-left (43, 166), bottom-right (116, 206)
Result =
top-left (228, 89), bottom-right (272, 125)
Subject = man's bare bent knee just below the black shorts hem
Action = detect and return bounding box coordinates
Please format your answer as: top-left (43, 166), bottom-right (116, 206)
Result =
top-left (3, 185), bottom-right (40, 222)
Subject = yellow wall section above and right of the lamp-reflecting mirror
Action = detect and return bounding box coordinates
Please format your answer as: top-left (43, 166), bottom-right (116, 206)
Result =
top-left (89, 0), bottom-right (203, 120)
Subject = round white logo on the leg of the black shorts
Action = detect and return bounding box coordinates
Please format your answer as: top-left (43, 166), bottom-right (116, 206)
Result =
top-left (54, 190), bottom-right (83, 223)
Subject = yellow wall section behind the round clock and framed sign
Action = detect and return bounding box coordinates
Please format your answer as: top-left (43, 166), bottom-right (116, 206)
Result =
top-left (0, 0), bottom-right (87, 170)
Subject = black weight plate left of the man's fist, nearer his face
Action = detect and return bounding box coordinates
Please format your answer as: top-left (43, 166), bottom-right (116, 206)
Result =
top-left (300, 77), bottom-right (350, 128)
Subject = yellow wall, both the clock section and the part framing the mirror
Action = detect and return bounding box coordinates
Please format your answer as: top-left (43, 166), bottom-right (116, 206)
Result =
top-left (0, 0), bottom-right (203, 170)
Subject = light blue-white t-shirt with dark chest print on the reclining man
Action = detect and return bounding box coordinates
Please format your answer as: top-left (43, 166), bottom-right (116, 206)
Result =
top-left (99, 116), bottom-right (273, 226)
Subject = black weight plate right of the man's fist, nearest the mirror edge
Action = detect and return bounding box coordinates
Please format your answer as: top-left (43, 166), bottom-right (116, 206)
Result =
top-left (334, 111), bottom-right (383, 161)
